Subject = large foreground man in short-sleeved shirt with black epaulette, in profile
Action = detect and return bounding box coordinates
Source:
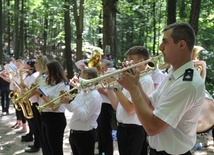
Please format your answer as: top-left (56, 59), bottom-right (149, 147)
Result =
top-left (118, 23), bottom-right (205, 155)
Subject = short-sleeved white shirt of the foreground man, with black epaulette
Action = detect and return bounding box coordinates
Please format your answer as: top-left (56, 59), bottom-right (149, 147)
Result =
top-left (149, 61), bottom-right (205, 154)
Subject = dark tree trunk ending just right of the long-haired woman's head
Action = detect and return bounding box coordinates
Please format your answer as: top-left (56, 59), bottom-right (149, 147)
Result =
top-left (64, 0), bottom-right (74, 79)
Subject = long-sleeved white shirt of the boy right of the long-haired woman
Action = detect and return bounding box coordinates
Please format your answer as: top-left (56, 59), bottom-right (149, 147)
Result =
top-left (66, 90), bottom-right (102, 131)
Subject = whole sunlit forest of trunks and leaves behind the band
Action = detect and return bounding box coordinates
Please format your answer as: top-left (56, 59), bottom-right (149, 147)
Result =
top-left (0, 0), bottom-right (214, 95)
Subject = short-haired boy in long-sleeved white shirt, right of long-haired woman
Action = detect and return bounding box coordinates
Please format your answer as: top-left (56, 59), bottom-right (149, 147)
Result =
top-left (61, 68), bottom-right (102, 155)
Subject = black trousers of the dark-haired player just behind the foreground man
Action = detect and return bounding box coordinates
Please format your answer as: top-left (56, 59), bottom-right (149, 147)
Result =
top-left (117, 123), bottom-right (147, 155)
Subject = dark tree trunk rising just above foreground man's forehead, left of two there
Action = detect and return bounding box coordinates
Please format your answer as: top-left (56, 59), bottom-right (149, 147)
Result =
top-left (167, 0), bottom-right (177, 25)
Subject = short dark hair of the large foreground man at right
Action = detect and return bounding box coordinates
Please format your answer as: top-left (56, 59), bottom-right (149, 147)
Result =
top-left (163, 23), bottom-right (195, 52)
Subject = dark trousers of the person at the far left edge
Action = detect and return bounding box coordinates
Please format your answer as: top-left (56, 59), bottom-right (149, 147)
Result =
top-left (1, 86), bottom-right (10, 113)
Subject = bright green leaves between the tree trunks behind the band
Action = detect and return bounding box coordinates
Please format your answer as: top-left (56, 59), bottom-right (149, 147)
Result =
top-left (3, 0), bottom-right (214, 95)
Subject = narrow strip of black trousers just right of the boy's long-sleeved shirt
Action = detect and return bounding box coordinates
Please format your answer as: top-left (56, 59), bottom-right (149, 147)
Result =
top-left (97, 103), bottom-right (114, 155)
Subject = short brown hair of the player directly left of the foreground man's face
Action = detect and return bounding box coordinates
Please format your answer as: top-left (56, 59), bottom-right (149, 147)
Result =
top-left (125, 46), bottom-right (150, 60)
